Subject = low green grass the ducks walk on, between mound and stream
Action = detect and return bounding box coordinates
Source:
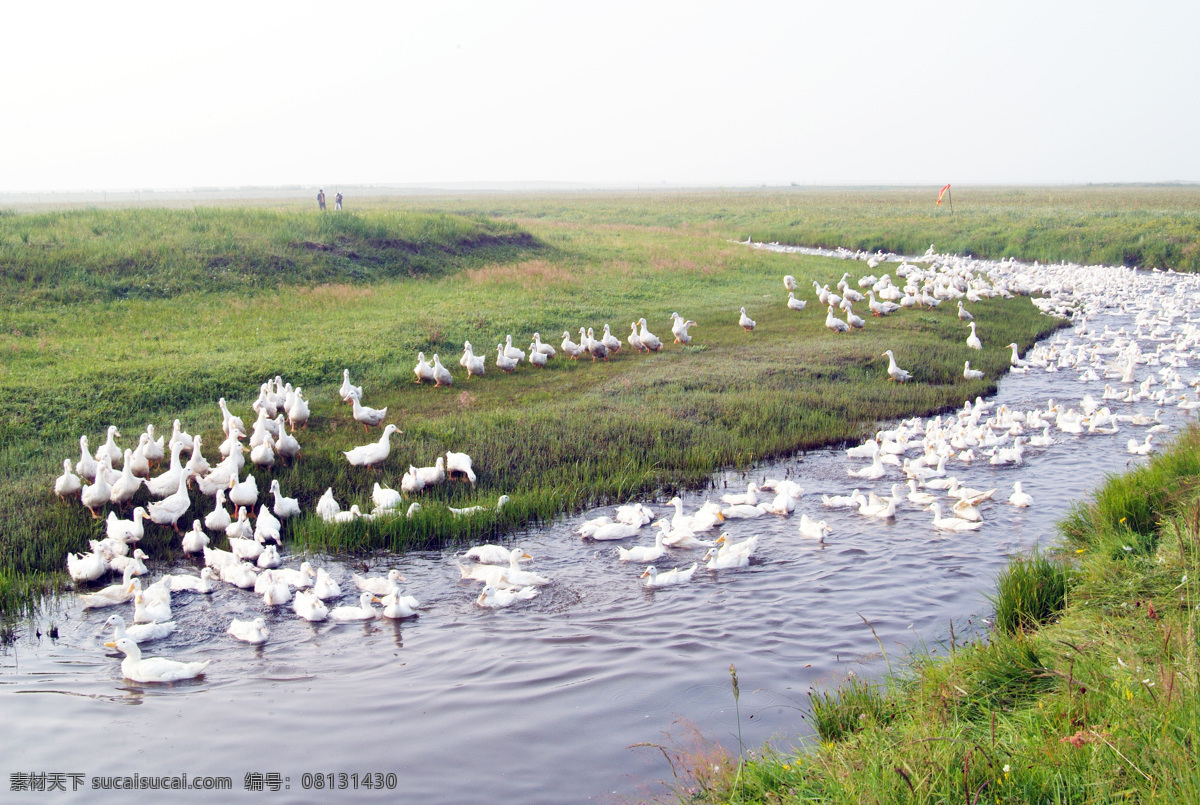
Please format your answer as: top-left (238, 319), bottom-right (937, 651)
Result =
top-left (0, 200), bottom-right (1058, 614)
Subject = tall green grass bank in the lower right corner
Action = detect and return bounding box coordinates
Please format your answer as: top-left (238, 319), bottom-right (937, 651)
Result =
top-left (696, 427), bottom-right (1200, 804)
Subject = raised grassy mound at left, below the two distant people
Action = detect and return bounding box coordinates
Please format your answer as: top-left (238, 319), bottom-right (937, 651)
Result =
top-left (0, 208), bottom-right (535, 307)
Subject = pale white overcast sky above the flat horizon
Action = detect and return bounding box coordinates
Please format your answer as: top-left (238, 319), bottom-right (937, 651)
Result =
top-left (0, 0), bottom-right (1200, 192)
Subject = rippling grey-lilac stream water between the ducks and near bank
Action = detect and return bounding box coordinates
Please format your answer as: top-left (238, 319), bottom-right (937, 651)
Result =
top-left (7, 255), bottom-right (1189, 803)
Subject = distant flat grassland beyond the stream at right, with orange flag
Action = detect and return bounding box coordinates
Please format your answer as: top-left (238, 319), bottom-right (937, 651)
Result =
top-left (420, 186), bottom-right (1200, 271)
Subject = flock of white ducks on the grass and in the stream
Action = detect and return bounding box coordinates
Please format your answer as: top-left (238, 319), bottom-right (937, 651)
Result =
top-left (54, 244), bottom-right (1200, 683)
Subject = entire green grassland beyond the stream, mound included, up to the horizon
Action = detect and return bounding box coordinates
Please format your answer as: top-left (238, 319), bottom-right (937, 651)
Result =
top-left (0, 187), bottom-right (1200, 621)
